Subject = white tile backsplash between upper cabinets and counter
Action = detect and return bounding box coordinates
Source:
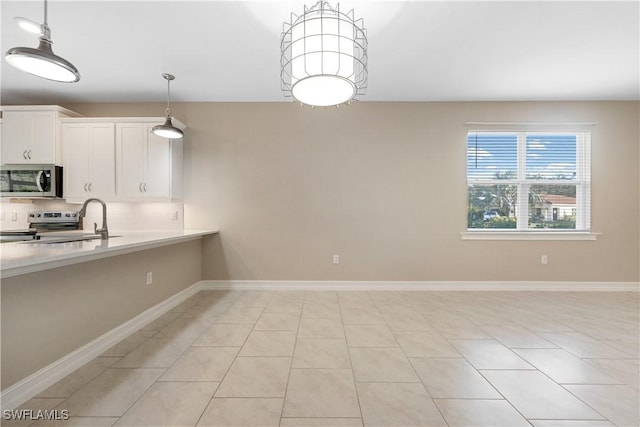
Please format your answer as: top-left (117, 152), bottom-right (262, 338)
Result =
top-left (0, 199), bottom-right (184, 230)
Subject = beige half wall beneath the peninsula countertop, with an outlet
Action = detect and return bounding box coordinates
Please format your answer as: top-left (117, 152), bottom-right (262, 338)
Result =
top-left (1, 240), bottom-right (202, 389)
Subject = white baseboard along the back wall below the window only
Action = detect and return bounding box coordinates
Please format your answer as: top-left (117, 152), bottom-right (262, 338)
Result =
top-left (200, 280), bottom-right (640, 292)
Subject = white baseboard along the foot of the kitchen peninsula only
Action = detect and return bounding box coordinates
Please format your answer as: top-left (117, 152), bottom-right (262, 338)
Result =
top-left (0, 282), bottom-right (202, 410)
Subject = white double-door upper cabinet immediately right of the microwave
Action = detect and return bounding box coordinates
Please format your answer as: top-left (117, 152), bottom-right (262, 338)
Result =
top-left (62, 119), bottom-right (116, 201)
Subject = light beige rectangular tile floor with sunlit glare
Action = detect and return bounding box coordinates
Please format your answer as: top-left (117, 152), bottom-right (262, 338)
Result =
top-left (10, 291), bottom-right (640, 427)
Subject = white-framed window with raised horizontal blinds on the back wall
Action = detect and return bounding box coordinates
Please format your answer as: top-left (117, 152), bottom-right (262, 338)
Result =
top-left (467, 132), bottom-right (591, 232)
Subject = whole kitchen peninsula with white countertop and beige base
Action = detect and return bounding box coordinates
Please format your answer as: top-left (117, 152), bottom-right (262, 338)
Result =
top-left (1, 230), bottom-right (217, 402)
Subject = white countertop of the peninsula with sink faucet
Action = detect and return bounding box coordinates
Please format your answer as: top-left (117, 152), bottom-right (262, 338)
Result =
top-left (0, 230), bottom-right (217, 278)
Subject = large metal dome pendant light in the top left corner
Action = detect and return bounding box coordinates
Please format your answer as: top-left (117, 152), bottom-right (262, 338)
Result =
top-left (4, 0), bottom-right (80, 83)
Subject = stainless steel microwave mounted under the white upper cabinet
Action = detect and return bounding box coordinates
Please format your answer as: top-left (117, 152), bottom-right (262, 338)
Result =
top-left (0, 165), bottom-right (62, 198)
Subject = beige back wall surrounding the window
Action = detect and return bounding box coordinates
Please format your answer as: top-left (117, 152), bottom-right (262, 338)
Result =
top-left (65, 102), bottom-right (640, 282)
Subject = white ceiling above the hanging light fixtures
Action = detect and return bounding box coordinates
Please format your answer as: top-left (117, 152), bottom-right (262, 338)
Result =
top-left (0, 0), bottom-right (640, 105)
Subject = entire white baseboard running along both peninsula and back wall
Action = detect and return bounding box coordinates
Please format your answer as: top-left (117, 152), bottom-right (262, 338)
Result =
top-left (0, 280), bottom-right (640, 410)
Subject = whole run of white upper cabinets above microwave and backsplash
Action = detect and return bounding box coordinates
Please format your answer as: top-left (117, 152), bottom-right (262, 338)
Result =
top-left (6, 110), bottom-right (185, 203)
